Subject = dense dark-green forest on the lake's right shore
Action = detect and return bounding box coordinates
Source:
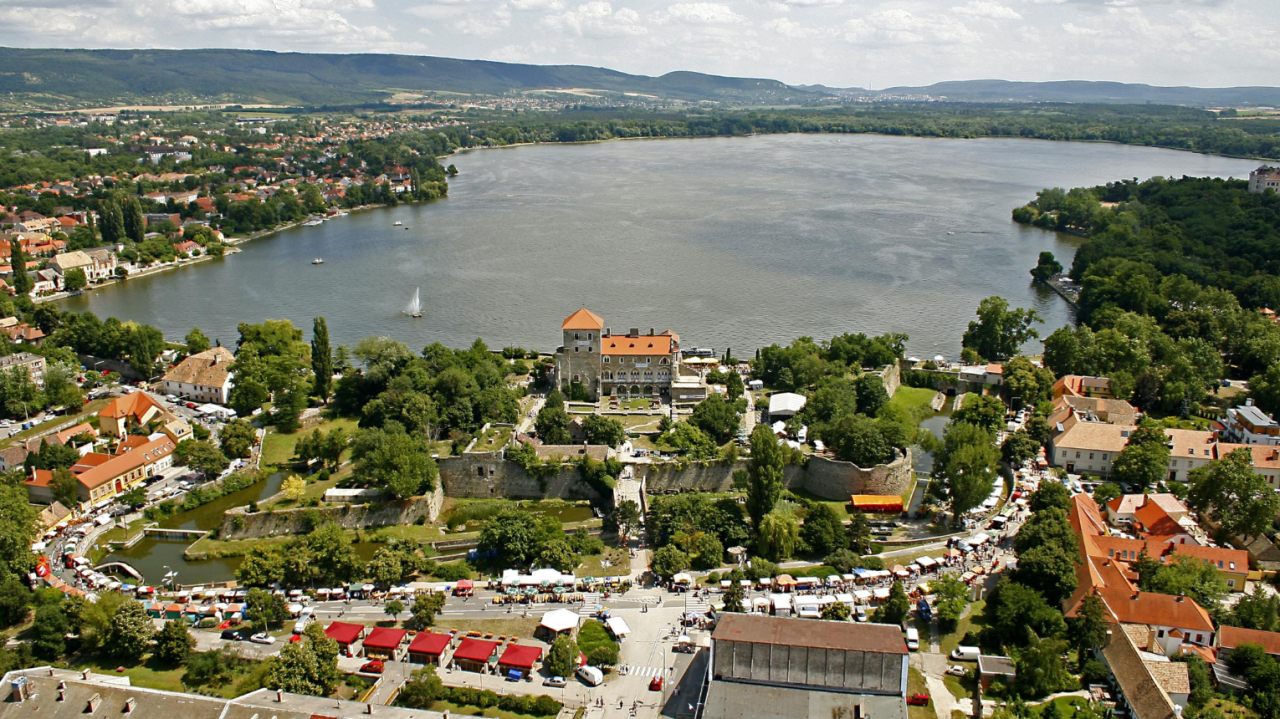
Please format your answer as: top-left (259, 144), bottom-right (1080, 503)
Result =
top-left (1014, 178), bottom-right (1280, 413)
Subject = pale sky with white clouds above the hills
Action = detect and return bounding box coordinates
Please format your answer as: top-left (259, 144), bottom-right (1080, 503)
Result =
top-left (0, 0), bottom-right (1280, 90)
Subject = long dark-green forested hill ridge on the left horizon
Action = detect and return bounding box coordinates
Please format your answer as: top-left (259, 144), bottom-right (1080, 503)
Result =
top-left (0, 47), bottom-right (814, 106)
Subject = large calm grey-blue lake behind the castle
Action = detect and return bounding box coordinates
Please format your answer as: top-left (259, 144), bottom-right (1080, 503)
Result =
top-left (65, 134), bottom-right (1257, 357)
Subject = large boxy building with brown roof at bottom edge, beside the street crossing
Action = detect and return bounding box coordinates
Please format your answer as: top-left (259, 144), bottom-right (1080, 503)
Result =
top-left (701, 614), bottom-right (908, 719)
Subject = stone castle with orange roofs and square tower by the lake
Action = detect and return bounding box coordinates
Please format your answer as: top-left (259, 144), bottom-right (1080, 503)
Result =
top-left (554, 307), bottom-right (680, 400)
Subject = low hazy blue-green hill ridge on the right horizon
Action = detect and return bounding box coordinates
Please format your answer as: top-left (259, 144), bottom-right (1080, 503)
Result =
top-left (855, 79), bottom-right (1280, 107)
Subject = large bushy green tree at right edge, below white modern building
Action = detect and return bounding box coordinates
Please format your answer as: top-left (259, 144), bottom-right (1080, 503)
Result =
top-left (1187, 449), bottom-right (1280, 539)
